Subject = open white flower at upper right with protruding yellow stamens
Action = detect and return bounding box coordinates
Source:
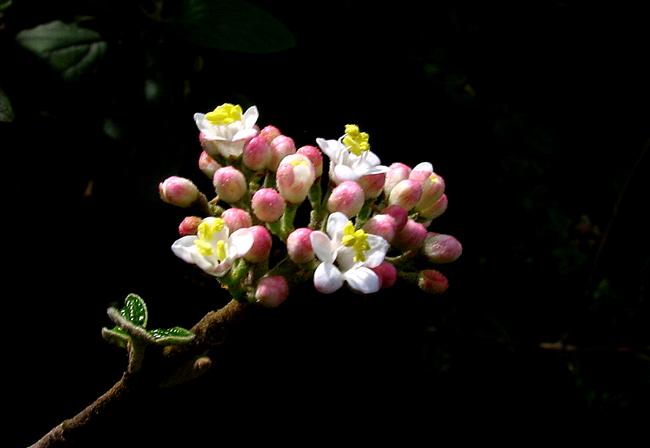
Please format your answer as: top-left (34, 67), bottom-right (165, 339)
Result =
top-left (316, 125), bottom-right (388, 184)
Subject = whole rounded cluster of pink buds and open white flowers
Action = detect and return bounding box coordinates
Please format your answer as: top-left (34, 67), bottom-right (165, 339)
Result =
top-left (159, 104), bottom-right (462, 307)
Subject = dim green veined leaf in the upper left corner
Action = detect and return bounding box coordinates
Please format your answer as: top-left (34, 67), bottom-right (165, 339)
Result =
top-left (16, 20), bottom-right (106, 81)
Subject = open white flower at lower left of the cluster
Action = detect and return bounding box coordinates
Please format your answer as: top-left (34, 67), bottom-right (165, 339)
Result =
top-left (172, 218), bottom-right (254, 277)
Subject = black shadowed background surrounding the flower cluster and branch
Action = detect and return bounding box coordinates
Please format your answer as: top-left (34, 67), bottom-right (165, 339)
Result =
top-left (5, 0), bottom-right (650, 446)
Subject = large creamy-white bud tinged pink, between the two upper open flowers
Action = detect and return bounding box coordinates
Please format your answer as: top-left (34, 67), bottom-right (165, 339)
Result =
top-left (276, 154), bottom-right (316, 204)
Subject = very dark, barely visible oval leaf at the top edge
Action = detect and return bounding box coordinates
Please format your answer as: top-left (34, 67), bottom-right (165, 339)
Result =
top-left (171, 0), bottom-right (295, 53)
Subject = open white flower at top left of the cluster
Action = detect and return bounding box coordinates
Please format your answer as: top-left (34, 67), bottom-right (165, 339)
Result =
top-left (194, 103), bottom-right (259, 158)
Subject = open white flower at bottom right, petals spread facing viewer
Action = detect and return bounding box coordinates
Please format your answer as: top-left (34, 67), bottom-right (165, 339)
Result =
top-left (310, 212), bottom-right (388, 294)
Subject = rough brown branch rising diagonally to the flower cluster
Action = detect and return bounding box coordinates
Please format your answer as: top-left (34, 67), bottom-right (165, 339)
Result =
top-left (31, 300), bottom-right (255, 448)
